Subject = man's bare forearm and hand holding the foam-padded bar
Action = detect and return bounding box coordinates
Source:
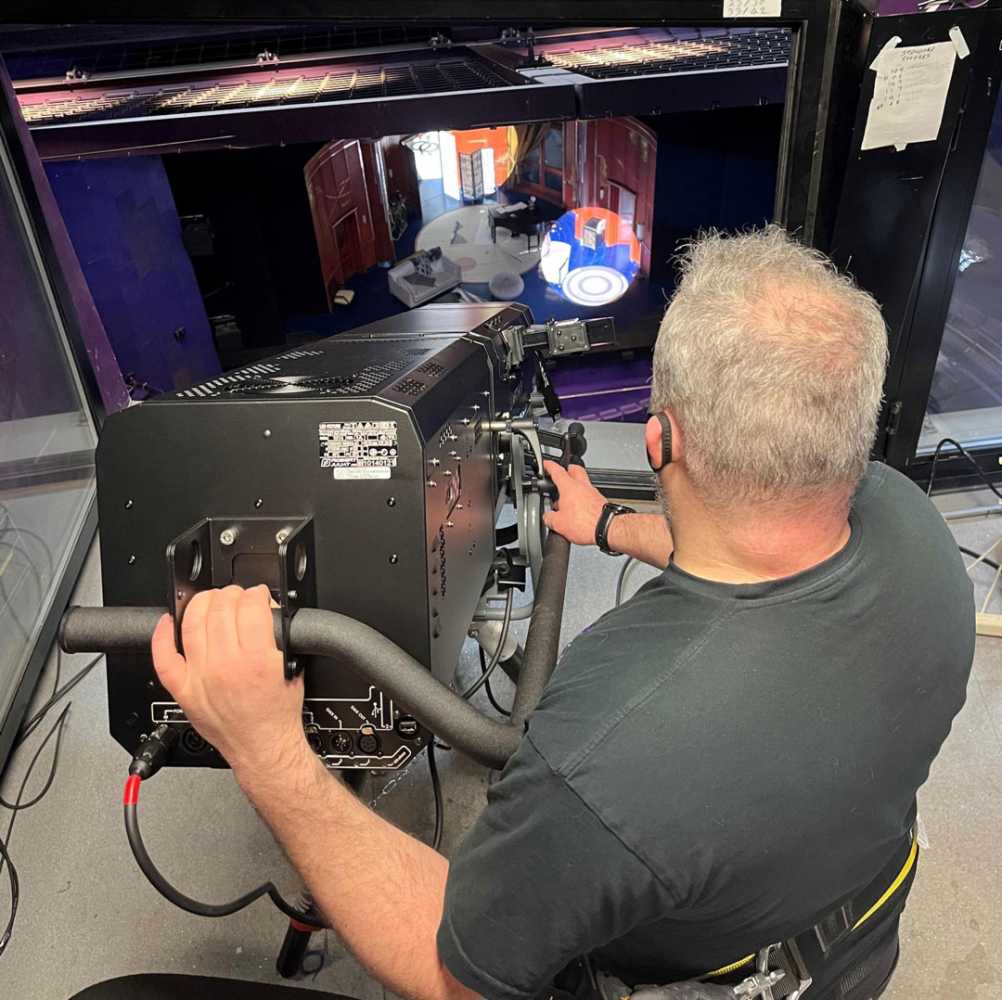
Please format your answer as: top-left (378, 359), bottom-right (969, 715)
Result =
top-left (153, 587), bottom-right (478, 1000)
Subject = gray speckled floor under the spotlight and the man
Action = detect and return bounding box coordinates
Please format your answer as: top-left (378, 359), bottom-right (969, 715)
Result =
top-left (0, 480), bottom-right (1002, 1000)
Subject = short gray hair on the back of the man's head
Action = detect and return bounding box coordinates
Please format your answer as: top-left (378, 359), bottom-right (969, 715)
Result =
top-left (651, 225), bottom-right (888, 508)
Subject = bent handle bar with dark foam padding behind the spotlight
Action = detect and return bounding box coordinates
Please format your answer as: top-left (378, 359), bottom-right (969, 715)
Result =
top-left (59, 531), bottom-right (570, 769)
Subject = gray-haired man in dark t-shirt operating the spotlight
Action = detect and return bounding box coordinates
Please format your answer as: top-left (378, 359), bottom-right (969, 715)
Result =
top-left (153, 227), bottom-right (974, 1000)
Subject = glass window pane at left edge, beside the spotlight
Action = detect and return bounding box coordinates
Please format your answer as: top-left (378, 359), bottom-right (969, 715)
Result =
top-left (0, 137), bottom-right (96, 720)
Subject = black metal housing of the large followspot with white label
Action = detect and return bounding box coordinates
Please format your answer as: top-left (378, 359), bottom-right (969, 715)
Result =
top-left (97, 304), bottom-right (532, 769)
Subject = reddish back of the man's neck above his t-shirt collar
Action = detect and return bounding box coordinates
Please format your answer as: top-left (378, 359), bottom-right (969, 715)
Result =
top-left (670, 478), bottom-right (851, 583)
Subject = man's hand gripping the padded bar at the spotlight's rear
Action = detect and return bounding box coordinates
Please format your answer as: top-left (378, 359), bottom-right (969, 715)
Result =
top-left (153, 586), bottom-right (307, 777)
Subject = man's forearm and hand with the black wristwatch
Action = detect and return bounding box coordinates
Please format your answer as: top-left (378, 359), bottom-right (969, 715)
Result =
top-left (543, 462), bottom-right (674, 569)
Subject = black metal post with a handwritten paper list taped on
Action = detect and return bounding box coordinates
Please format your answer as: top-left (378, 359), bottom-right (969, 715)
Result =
top-left (831, 0), bottom-right (1002, 488)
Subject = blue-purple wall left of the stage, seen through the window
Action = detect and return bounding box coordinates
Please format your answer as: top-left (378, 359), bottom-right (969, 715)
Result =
top-left (45, 156), bottom-right (220, 391)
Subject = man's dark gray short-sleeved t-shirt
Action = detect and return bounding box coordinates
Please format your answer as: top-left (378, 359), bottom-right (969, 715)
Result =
top-left (438, 464), bottom-right (974, 1000)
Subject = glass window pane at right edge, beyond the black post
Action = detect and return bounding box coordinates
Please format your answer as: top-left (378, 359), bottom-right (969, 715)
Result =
top-left (919, 92), bottom-right (1002, 453)
